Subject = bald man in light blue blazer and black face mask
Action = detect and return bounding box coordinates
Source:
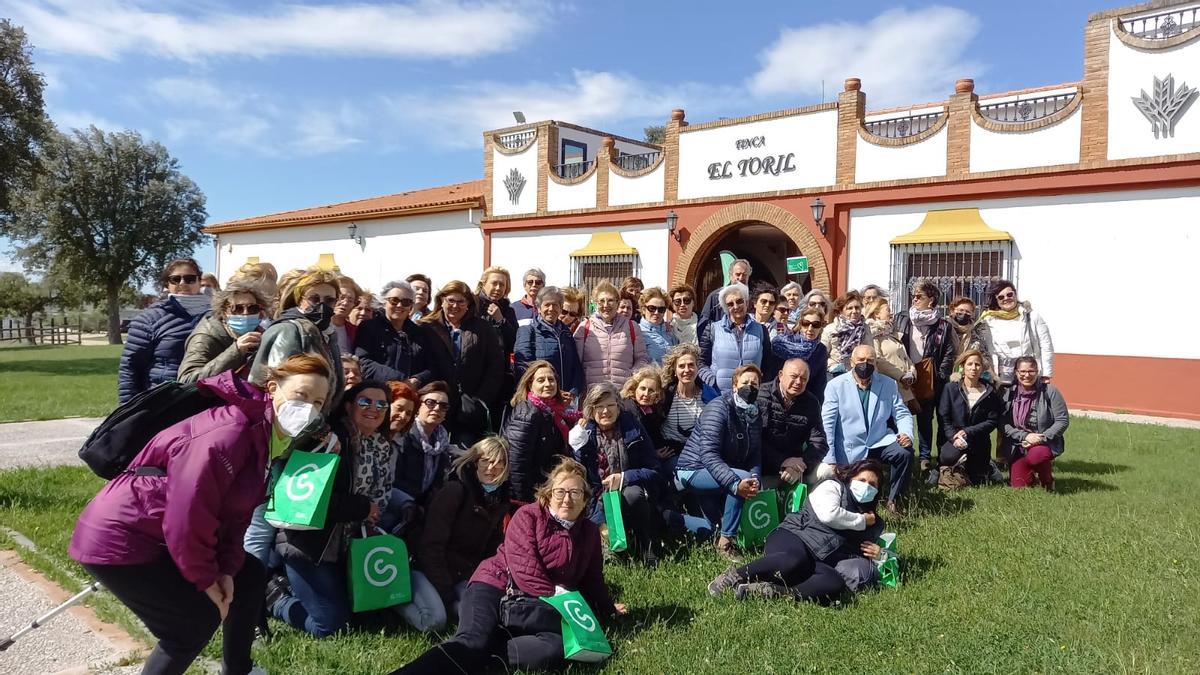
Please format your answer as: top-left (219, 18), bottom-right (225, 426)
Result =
top-left (817, 345), bottom-right (912, 515)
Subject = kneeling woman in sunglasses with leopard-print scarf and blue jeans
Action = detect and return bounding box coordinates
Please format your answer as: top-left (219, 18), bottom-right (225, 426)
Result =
top-left (266, 380), bottom-right (395, 638)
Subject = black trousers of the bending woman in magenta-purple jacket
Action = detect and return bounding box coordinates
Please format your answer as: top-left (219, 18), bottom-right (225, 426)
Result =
top-left (83, 555), bottom-right (266, 675)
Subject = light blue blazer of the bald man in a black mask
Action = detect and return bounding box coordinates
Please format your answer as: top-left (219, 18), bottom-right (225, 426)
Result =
top-left (821, 372), bottom-right (913, 464)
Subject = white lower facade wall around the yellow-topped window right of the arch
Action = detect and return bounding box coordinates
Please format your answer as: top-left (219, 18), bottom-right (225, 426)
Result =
top-left (848, 187), bottom-right (1200, 359)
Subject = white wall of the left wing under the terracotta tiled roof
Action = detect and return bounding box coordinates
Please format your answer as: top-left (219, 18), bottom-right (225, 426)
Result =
top-left (217, 209), bottom-right (484, 292)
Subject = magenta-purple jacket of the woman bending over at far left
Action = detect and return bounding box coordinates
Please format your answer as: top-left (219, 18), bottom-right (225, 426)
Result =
top-left (70, 371), bottom-right (274, 591)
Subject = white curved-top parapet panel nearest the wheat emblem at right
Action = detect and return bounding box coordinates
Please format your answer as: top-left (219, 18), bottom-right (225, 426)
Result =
top-left (971, 106), bottom-right (1084, 172)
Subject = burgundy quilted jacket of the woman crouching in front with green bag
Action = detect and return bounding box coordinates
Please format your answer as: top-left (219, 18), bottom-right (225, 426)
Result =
top-left (470, 502), bottom-right (616, 616)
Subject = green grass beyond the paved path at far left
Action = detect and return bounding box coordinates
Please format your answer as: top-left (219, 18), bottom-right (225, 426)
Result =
top-left (0, 345), bottom-right (121, 423)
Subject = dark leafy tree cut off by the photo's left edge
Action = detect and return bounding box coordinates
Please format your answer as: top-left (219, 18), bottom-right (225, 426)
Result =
top-left (0, 19), bottom-right (54, 214)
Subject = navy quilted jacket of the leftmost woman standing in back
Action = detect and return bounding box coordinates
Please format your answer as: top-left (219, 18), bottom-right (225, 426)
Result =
top-left (116, 298), bottom-right (204, 404)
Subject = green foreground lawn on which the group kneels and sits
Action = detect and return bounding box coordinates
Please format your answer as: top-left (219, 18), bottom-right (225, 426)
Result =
top-left (0, 418), bottom-right (1200, 674)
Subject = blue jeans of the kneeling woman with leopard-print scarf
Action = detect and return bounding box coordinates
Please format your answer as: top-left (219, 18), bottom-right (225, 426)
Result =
top-left (269, 558), bottom-right (350, 638)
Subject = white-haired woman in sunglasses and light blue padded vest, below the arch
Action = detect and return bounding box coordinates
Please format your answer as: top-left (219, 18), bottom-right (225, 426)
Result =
top-left (700, 283), bottom-right (772, 392)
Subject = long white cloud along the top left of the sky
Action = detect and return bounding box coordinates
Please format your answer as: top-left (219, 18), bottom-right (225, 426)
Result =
top-left (0, 0), bottom-right (550, 61)
